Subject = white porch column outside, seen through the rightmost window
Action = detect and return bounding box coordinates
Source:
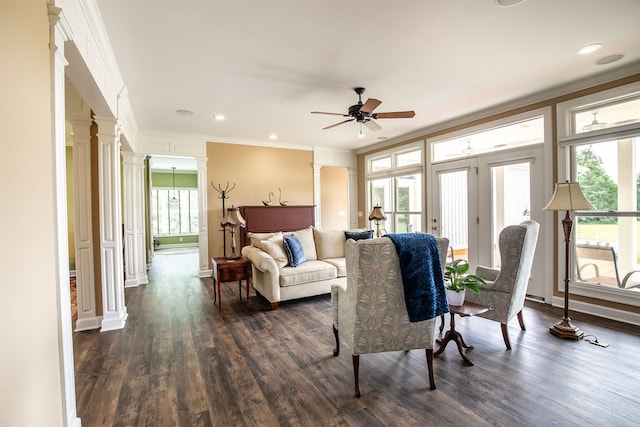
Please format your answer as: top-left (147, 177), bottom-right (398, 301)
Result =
top-left (617, 139), bottom-right (638, 274)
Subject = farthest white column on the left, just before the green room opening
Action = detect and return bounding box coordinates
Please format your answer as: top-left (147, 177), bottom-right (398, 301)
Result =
top-left (122, 152), bottom-right (149, 288)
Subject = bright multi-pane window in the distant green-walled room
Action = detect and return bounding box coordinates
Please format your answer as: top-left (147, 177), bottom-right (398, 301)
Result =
top-left (151, 188), bottom-right (198, 236)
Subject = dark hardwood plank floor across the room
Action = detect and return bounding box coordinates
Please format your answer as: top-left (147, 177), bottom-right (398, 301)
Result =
top-left (74, 254), bottom-right (640, 426)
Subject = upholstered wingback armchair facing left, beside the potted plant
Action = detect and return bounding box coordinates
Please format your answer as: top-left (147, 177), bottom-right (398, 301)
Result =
top-left (465, 221), bottom-right (540, 350)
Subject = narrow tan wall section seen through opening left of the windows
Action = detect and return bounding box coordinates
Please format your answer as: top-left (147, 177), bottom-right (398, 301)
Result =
top-left (320, 166), bottom-right (349, 230)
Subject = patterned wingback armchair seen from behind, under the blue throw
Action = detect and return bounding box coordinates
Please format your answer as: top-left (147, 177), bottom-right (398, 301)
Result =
top-left (331, 237), bottom-right (449, 397)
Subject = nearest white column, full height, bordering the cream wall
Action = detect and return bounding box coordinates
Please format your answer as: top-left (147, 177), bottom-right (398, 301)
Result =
top-left (49, 6), bottom-right (80, 425)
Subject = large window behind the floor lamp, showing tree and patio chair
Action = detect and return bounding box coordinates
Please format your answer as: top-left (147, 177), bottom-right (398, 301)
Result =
top-left (558, 84), bottom-right (640, 305)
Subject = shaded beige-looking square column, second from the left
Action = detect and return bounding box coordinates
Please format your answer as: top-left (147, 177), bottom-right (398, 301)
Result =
top-left (67, 113), bottom-right (100, 331)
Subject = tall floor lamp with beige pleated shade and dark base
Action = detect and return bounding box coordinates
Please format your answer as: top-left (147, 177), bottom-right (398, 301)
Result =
top-left (544, 181), bottom-right (593, 340)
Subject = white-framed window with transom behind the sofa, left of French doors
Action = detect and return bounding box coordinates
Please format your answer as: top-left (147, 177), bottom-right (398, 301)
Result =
top-left (366, 143), bottom-right (424, 233)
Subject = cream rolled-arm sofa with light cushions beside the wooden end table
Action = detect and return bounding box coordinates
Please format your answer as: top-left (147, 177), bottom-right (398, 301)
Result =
top-left (241, 227), bottom-right (373, 310)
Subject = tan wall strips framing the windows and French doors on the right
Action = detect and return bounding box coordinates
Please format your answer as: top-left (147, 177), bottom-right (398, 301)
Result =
top-left (357, 74), bottom-right (640, 313)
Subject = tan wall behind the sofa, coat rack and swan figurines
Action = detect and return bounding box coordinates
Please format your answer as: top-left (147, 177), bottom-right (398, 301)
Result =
top-left (207, 142), bottom-right (314, 257)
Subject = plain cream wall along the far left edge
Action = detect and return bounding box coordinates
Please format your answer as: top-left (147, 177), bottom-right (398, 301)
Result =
top-left (0, 0), bottom-right (64, 426)
